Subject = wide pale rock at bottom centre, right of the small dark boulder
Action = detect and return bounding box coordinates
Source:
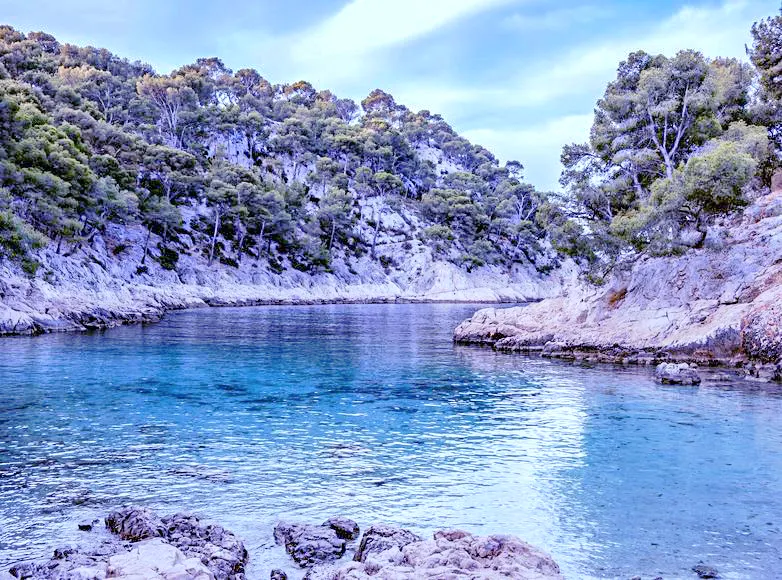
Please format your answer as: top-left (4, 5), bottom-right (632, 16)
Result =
top-left (306, 526), bottom-right (562, 580)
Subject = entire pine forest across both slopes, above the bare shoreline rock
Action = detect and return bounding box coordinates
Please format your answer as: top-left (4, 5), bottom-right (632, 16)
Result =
top-left (0, 7), bottom-right (782, 281)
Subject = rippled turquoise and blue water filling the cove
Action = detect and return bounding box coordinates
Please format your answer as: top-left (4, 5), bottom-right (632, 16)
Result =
top-left (0, 305), bottom-right (782, 579)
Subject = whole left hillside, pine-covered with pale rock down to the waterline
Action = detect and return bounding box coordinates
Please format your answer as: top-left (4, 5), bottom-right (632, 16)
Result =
top-left (0, 26), bottom-right (560, 333)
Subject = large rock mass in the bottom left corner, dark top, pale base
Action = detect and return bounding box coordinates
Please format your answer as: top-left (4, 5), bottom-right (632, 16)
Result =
top-left (9, 507), bottom-right (249, 580)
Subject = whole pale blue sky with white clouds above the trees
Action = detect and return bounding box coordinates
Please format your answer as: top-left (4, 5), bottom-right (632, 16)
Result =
top-left (0, 0), bottom-right (780, 189)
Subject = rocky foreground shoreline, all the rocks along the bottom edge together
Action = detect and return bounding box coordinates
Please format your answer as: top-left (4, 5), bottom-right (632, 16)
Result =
top-left (0, 507), bottom-right (563, 580)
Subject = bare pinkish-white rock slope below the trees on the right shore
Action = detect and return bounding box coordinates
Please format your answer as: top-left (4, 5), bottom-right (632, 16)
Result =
top-left (454, 192), bottom-right (782, 378)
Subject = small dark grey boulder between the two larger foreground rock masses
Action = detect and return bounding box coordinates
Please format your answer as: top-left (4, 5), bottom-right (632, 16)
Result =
top-left (274, 522), bottom-right (346, 568)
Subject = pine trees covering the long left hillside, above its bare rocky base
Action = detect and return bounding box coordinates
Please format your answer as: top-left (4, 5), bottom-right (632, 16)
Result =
top-left (0, 26), bottom-right (544, 273)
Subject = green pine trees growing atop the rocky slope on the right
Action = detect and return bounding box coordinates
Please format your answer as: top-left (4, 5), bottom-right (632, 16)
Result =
top-left (550, 8), bottom-right (782, 281)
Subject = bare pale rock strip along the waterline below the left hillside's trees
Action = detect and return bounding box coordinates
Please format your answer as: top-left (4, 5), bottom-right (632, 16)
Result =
top-left (0, 215), bottom-right (569, 335)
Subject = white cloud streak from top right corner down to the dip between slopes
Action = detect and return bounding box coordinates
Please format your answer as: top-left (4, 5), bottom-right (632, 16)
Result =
top-left (395, 0), bottom-right (777, 189)
